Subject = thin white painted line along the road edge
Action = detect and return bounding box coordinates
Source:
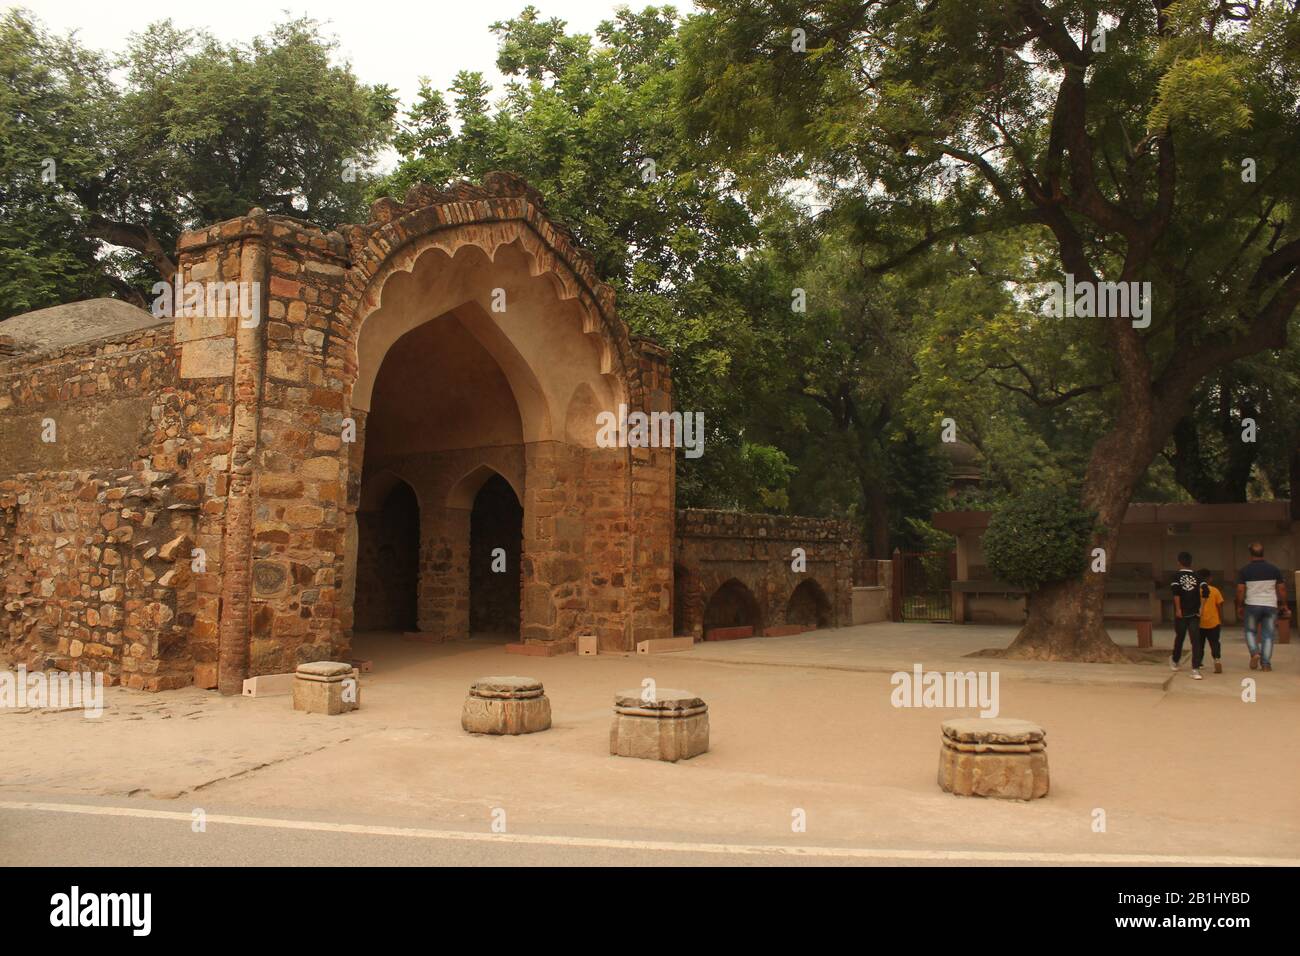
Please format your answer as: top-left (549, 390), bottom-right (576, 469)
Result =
top-left (0, 800), bottom-right (1300, 866)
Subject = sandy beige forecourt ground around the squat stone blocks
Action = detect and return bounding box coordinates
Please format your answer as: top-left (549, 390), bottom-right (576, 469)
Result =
top-left (0, 624), bottom-right (1300, 862)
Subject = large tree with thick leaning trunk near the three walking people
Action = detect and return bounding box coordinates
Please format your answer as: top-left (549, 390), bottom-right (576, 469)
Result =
top-left (683, 0), bottom-right (1300, 661)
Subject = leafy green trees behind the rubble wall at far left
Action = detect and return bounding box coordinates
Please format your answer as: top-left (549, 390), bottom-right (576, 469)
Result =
top-left (0, 10), bottom-right (397, 315)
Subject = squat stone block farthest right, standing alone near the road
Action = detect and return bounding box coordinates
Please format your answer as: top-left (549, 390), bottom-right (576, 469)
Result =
top-left (939, 717), bottom-right (1048, 800)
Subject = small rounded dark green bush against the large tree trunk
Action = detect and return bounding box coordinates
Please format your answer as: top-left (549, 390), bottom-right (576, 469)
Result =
top-left (983, 489), bottom-right (1096, 589)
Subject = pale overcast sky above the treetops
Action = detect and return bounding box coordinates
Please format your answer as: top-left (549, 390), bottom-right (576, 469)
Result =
top-left (22, 0), bottom-right (693, 108)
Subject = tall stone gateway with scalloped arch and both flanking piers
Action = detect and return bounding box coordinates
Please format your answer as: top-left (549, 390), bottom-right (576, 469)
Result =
top-left (187, 173), bottom-right (675, 693)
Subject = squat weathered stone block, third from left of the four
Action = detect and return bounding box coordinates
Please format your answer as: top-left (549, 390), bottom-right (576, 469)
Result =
top-left (610, 688), bottom-right (709, 762)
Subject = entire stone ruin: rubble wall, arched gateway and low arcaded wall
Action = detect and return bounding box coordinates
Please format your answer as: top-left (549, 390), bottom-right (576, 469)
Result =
top-left (0, 173), bottom-right (852, 693)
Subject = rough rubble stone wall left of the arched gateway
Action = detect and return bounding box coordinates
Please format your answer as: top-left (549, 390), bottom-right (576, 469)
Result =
top-left (0, 323), bottom-right (231, 689)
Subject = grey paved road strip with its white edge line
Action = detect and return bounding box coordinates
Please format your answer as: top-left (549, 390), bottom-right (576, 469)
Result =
top-left (0, 795), bottom-right (1300, 866)
